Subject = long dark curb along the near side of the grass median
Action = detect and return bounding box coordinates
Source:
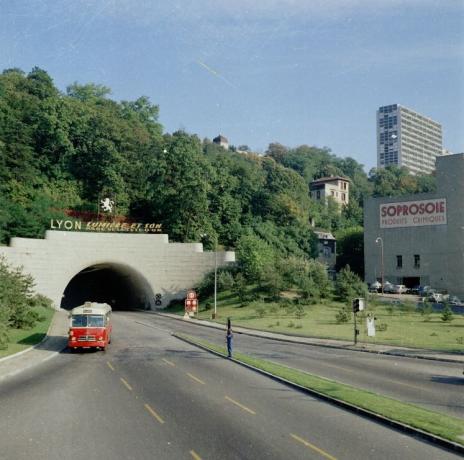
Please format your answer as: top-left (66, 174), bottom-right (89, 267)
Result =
top-left (172, 333), bottom-right (464, 454)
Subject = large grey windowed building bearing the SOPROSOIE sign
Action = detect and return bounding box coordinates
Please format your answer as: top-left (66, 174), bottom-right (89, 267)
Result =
top-left (364, 153), bottom-right (464, 299)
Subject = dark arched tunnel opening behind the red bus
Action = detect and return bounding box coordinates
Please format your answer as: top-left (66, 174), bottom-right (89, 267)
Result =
top-left (61, 264), bottom-right (154, 310)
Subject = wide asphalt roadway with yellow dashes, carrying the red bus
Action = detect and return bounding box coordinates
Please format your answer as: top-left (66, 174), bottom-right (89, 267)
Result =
top-left (0, 313), bottom-right (460, 460)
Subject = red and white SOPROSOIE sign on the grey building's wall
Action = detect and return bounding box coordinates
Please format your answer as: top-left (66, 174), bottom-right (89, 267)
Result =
top-left (379, 198), bottom-right (447, 228)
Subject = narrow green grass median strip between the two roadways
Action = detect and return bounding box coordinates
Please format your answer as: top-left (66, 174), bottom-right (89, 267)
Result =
top-left (174, 334), bottom-right (464, 445)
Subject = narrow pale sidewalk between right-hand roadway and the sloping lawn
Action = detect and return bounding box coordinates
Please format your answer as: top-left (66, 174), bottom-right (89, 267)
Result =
top-left (153, 312), bottom-right (464, 364)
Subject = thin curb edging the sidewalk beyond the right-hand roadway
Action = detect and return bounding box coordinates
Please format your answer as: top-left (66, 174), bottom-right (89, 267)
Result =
top-left (152, 311), bottom-right (464, 365)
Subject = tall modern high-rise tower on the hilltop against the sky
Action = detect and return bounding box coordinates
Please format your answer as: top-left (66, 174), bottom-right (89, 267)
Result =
top-left (377, 104), bottom-right (443, 174)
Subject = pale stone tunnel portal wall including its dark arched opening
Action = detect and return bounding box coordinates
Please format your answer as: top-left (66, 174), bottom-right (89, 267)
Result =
top-left (0, 230), bottom-right (235, 309)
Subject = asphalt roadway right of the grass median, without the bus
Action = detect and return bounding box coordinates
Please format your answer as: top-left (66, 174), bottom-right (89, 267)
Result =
top-left (144, 313), bottom-right (464, 418)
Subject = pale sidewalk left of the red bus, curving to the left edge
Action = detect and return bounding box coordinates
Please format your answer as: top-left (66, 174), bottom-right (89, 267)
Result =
top-left (0, 310), bottom-right (68, 381)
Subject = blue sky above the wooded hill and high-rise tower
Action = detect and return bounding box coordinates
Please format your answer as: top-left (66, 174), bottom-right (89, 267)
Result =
top-left (0, 0), bottom-right (464, 172)
